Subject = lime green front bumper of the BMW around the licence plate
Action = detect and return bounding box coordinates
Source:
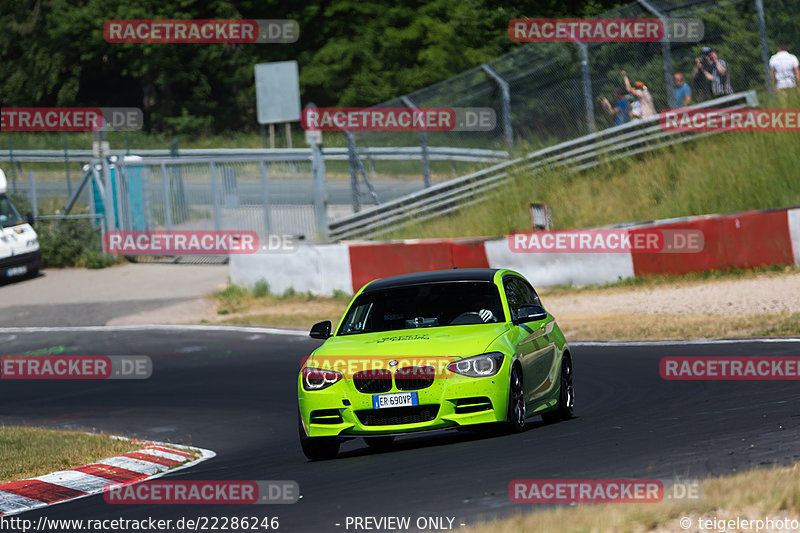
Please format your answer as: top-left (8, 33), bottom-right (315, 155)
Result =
top-left (297, 360), bottom-right (509, 437)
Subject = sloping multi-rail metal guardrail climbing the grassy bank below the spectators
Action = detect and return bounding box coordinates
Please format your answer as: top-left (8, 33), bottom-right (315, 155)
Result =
top-left (329, 91), bottom-right (758, 240)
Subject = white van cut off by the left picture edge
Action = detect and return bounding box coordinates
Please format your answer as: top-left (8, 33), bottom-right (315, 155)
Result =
top-left (0, 169), bottom-right (42, 281)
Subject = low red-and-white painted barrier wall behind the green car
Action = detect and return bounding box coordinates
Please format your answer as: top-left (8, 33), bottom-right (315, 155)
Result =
top-left (230, 208), bottom-right (800, 295)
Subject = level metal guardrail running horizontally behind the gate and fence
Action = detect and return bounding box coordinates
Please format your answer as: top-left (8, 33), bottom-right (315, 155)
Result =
top-left (0, 146), bottom-right (509, 163)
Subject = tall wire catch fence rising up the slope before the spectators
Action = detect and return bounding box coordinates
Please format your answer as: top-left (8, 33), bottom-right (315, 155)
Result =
top-left (356, 0), bottom-right (800, 153)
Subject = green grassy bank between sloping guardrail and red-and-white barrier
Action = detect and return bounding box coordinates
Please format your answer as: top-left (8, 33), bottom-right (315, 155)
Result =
top-left (386, 96), bottom-right (800, 239)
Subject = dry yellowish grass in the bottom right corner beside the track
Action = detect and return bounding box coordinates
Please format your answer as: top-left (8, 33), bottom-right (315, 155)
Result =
top-left (463, 465), bottom-right (800, 533)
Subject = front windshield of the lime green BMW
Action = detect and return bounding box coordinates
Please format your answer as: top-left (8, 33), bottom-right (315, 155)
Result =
top-left (339, 281), bottom-right (503, 335)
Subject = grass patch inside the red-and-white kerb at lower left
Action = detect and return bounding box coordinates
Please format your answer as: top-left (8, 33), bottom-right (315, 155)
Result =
top-left (0, 426), bottom-right (141, 483)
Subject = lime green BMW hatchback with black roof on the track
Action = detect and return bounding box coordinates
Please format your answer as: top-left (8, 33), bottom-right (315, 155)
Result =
top-left (297, 269), bottom-right (574, 460)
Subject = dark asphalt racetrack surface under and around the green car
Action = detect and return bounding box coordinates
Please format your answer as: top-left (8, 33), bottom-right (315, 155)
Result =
top-left (0, 327), bottom-right (800, 532)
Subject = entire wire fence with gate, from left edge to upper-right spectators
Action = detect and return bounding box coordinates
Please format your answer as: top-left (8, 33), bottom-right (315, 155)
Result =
top-left (0, 0), bottom-right (800, 252)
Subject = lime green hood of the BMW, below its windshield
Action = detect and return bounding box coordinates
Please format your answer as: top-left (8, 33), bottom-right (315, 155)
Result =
top-left (312, 322), bottom-right (508, 358)
